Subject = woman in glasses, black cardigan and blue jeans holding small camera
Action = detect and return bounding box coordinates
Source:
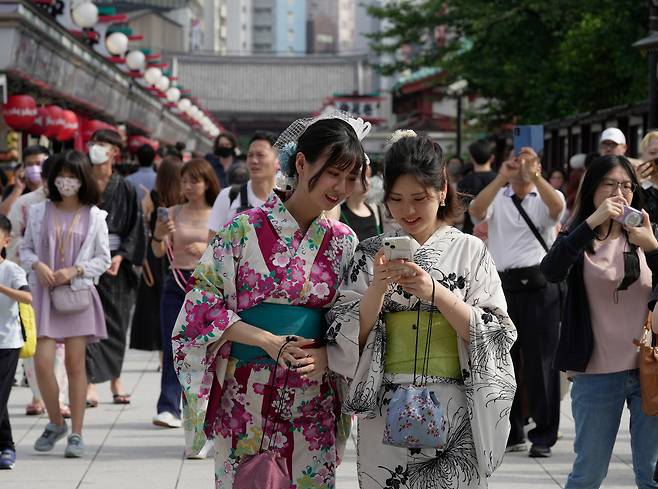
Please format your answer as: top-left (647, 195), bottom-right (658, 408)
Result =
top-left (541, 155), bottom-right (658, 489)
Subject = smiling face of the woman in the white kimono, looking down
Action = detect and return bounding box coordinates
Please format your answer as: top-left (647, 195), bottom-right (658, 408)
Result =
top-left (386, 174), bottom-right (447, 237)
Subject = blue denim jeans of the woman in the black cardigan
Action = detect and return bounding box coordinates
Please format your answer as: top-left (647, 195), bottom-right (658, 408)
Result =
top-left (565, 370), bottom-right (658, 489)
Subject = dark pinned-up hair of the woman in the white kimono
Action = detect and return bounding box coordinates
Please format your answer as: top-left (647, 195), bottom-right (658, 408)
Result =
top-left (384, 132), bottom-right (463, 219)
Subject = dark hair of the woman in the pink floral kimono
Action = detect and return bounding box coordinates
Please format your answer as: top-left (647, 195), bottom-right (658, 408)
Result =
top-left (280, 119), bottom-right (368, 190)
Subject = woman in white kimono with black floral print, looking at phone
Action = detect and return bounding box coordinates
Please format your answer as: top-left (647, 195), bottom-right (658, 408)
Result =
top-left (328, 131), bottom-right (516, 489)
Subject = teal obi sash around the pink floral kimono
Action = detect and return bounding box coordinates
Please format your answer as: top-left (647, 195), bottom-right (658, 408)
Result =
top-left (231, 302), bottom-right (327, 364)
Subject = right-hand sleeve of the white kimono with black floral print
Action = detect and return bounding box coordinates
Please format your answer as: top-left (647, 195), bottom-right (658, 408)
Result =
top-left (458, 240), bottom-right (516, 476)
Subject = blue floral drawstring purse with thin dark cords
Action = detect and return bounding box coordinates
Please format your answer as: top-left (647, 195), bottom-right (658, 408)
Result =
top-left (383, 280), bottom-right (447, 448)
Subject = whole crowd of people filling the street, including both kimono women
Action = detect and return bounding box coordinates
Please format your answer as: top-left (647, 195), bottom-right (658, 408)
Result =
top-left (0, 112), bottom-right (658, 489)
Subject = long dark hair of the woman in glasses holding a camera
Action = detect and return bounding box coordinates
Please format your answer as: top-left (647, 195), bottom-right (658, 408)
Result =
top-left (569, 155), bottom-right (644, 248)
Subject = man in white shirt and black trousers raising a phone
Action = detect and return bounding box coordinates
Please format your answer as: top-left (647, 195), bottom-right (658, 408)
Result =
top-left (469, 147), bottom-right (566, 457)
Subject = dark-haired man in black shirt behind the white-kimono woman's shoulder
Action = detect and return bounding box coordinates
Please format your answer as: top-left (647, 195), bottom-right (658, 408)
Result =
top-left (457, 139), bottom-right (496, 234)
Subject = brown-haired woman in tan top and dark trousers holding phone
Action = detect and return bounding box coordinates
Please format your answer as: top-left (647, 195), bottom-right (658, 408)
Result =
top-left (151, 158), bottom-right (219, 428)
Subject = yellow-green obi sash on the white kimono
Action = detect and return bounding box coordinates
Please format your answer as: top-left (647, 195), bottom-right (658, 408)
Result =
top-left (384, 311), bottom-right (462, 379)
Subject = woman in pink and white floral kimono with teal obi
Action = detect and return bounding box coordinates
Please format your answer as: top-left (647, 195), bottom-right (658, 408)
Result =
top-left (172, 116), bottom-right (369, 489)
